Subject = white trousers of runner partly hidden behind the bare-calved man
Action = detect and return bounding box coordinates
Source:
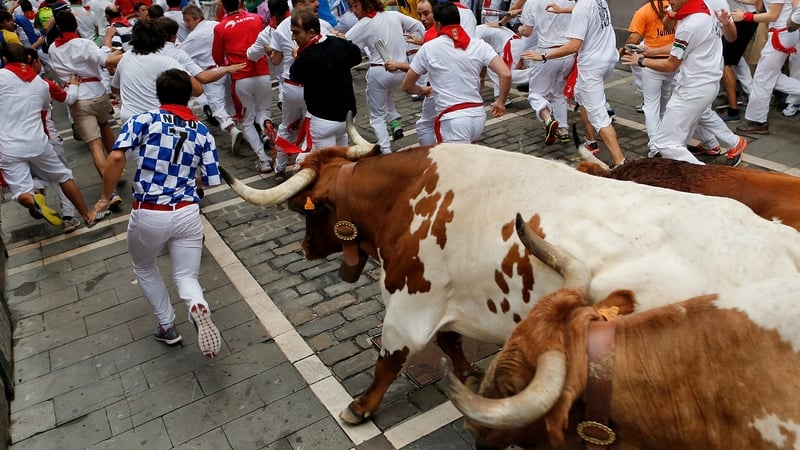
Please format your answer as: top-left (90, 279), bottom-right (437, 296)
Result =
top-left (528, 54), bottom-right (572, 128)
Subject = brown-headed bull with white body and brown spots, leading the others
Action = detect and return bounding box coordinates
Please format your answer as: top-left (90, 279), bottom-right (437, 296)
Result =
top-left (223, 125), bottom-right (800, 423)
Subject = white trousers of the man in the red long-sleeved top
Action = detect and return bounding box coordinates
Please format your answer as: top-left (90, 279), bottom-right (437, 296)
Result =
top-left (234, 75), bottom-right (272, 161)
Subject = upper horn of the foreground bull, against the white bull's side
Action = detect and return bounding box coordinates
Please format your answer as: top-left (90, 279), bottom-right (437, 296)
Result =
top-left (517, 213), bottom-right (591, 297)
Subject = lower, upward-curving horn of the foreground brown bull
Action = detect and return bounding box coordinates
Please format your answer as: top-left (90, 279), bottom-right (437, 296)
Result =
top-left (442, 350), bottom-right (567, 430)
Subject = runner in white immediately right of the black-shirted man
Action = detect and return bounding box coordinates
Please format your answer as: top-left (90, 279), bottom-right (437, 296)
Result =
top-left (346, 0), bottom-right (425, 153)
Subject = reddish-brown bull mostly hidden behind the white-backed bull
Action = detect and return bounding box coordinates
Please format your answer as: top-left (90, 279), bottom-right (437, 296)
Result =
top-left (578, 158), bottom-right (800, 231)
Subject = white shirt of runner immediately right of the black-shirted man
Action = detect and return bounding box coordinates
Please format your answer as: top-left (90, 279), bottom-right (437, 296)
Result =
top-left (345, 11), bottom-right (425, 64)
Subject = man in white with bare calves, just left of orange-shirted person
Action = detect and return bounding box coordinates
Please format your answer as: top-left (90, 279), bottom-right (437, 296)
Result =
top-left (524, 0), bottom-right (625, 165)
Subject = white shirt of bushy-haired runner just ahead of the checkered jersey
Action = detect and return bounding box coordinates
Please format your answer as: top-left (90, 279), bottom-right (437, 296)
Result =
top-left (111, 52), bottom-right (185, 122)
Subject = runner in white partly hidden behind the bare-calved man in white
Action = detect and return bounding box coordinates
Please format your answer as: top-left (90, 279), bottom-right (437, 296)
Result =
top-left (519, 0), bottom-right (575, 145)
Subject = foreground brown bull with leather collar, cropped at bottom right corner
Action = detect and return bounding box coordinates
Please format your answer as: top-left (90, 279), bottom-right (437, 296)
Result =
top-left (444, 229), bottom-right (800, 450)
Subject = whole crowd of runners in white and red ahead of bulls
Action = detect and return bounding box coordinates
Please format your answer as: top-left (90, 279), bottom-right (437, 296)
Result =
top-left (0, 0), bottom-right (800, 356)
